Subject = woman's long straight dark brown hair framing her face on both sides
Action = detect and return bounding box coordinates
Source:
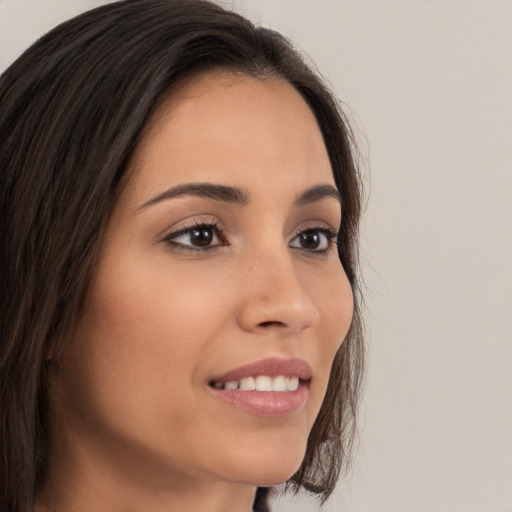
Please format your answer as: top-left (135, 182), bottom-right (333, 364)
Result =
top-left (0, 0), bottom-right (364, 512)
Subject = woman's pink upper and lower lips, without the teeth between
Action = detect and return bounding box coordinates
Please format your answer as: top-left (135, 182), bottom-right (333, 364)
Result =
top-left (208, 358), bottom-right (313, 418)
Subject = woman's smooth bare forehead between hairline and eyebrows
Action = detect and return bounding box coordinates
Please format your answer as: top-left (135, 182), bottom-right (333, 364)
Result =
top-left (122, 72), bottom-right (334, 206)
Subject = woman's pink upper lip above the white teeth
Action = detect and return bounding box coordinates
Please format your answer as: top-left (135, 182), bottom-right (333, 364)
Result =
top-left (210, 357), bottom-right (313, 382)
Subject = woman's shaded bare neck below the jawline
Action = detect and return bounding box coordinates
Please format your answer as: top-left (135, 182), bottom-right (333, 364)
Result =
top-left (35, 432), bottom-right (256, 512)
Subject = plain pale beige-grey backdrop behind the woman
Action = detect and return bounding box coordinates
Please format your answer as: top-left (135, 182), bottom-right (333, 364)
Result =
top-left (0, 0), bottom-right (512, 512)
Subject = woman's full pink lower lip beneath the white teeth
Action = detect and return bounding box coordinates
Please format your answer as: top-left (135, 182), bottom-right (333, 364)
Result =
top-left (210, 381), bottom-right (309, 418)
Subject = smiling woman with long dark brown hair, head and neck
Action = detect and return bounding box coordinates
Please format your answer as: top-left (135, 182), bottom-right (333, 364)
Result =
top-left (0, 0), bottom-right (363, 512)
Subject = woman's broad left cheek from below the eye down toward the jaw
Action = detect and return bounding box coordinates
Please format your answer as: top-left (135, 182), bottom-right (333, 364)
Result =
top-left (60, 259), bottom-right (234, 428)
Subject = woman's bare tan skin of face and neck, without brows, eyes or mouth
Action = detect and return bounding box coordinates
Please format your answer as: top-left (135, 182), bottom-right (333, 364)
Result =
top-left (37, 72), bottom-right (352, 512)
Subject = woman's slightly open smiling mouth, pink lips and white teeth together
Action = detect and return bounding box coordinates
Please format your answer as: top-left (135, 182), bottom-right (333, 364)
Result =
top-left (209, 358), bottom-right (312, 418)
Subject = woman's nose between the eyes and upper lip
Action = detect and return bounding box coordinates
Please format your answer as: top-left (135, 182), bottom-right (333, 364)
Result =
top-left (238, 247), bottom-right (320, 336)
